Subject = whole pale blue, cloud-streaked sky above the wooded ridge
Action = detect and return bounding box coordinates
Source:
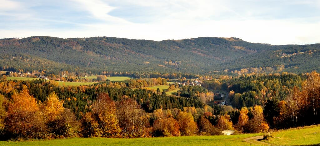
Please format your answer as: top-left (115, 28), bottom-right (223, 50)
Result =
top-left (0, 0), bottom-right (320, 45)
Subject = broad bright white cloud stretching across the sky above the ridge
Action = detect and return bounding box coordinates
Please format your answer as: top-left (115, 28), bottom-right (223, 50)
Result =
top-left (0, 0), bottom-right (320, 44)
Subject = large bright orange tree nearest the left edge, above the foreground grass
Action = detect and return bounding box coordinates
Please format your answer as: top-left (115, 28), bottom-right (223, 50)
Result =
top-left (5, 86), bottom-right (45, 138)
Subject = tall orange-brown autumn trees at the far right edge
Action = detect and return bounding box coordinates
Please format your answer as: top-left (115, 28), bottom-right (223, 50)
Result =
top-left (275, 72), bottom-right (320, 128)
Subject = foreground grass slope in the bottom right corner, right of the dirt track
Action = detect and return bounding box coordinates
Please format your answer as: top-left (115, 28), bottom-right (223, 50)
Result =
top-left (266, 125), bottom-right (320, 145)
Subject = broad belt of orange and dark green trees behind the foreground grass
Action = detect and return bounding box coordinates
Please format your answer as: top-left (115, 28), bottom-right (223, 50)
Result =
top-left (0, 72), bottom-right (320, 139)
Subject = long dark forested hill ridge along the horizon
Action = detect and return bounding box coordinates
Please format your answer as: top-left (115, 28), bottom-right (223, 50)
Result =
top-left (0, 37), bottom-right (320, 74)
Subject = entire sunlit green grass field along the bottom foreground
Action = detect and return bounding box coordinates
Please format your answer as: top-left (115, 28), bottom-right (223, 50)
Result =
top-left (0, 125), bottom-right (320, 146)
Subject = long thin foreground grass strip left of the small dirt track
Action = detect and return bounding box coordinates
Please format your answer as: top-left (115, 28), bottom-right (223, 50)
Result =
top-left (0, 134), bottom-right (257, 146)
